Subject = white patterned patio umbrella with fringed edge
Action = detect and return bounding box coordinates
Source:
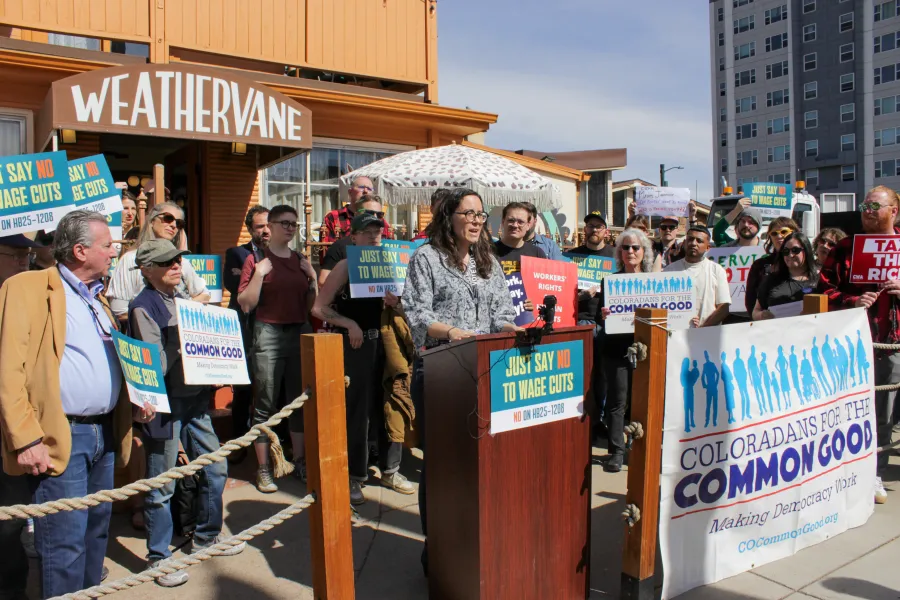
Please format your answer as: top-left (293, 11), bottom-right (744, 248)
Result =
top-left (340, 144), bottom-right (562, 211)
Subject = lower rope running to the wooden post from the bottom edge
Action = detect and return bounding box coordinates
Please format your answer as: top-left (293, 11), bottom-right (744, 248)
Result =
top-left (52, 494), bottom-right (316, 600)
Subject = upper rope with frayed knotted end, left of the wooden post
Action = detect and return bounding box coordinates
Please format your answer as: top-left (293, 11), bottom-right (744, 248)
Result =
top-left (0, 389), bottom-right (309, 521)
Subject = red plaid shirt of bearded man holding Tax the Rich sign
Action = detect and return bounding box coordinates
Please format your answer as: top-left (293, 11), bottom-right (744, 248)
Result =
top-left (819, 227), bottom-right (900, 354)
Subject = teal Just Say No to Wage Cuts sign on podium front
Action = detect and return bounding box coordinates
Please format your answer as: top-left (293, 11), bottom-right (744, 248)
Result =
top-left (490, 342), bottom-right (584, 435)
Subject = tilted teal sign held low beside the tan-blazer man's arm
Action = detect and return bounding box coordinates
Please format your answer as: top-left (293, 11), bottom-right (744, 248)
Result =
top-left (111, 330), bottom-right (172, 413)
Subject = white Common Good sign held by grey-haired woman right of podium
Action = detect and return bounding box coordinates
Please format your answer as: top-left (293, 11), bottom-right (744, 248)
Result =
top-left (603, 273), bottom-right (699, 333)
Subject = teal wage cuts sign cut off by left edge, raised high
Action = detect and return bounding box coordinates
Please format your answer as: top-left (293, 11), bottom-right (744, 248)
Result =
top-left (0, 152), bottom-right (75, 236)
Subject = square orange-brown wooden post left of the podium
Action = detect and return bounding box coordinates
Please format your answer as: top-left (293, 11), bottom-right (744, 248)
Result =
top-left (300, 333), bottom-right (355, 600)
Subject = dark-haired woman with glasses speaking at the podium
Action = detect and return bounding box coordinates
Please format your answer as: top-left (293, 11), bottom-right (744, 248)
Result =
top-left (403, 188), bottom-right (520, 574)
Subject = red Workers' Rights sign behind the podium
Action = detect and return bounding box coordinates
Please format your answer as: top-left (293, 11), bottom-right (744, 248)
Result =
top-left (522, 256), bottom-right (578, 327)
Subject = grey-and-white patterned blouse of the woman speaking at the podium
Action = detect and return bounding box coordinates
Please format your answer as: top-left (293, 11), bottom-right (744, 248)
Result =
top-left (403, 244), bottom-right (516, 348)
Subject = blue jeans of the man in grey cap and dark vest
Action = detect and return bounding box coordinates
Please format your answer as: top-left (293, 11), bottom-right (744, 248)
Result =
top-left (144, 392), bottom-right (228, 561)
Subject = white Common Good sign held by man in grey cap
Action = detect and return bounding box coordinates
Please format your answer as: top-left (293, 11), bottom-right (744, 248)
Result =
top-left (175, 298), bottom-right (250, 385)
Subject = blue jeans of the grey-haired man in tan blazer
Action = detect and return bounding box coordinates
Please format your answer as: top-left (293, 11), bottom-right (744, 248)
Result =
top-left (29, 419), bottom-right (115, 598)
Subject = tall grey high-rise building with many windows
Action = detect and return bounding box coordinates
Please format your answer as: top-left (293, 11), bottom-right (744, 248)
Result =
top-left (709, 0), bottom-right (900, 211)
